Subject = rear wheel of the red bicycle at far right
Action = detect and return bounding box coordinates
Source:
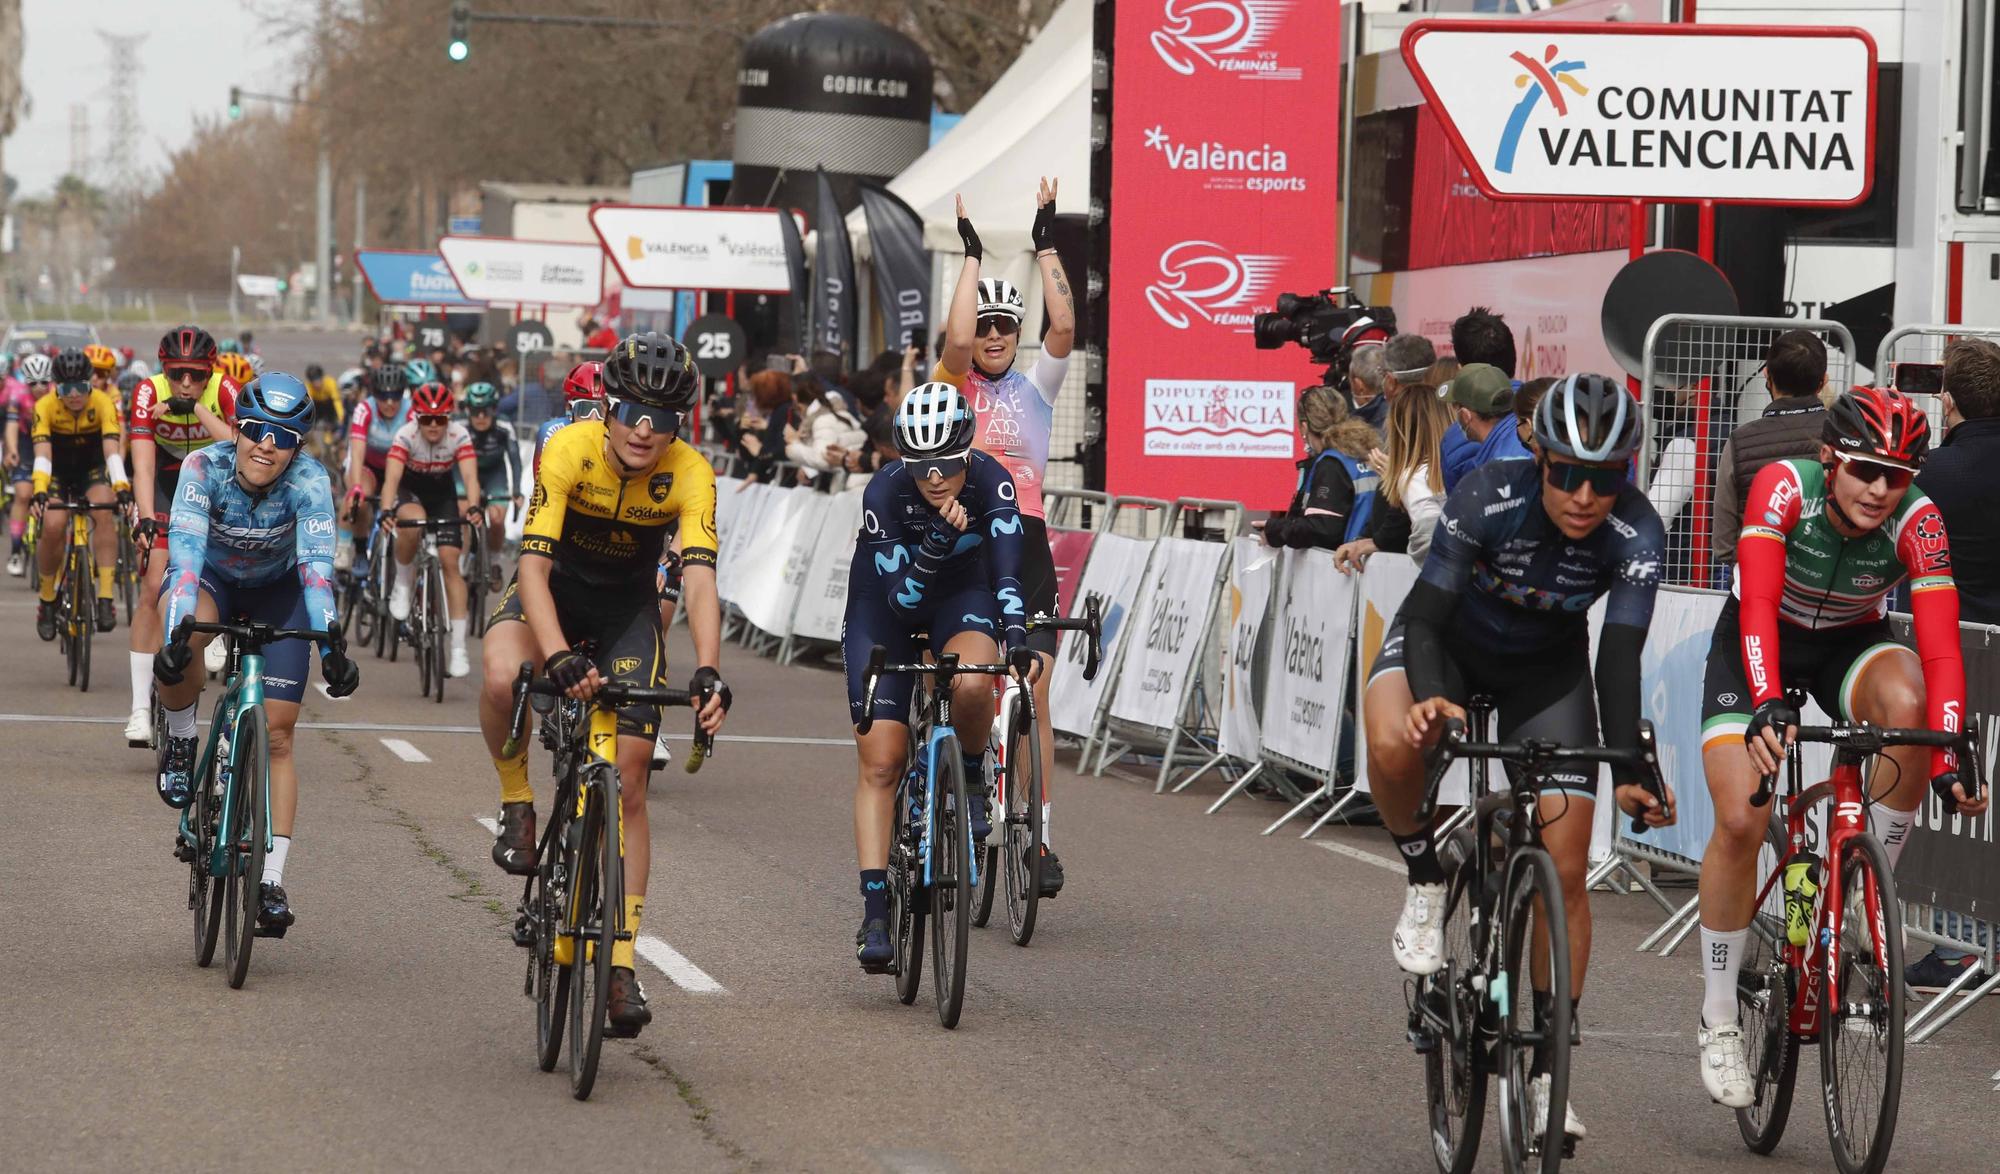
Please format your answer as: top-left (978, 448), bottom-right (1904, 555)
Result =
top-left (1736, 814), bottom-right (1798, 1154)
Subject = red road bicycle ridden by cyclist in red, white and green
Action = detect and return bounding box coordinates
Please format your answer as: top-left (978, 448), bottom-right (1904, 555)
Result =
top-left (1736, 694), bottom-right (1984, 1174)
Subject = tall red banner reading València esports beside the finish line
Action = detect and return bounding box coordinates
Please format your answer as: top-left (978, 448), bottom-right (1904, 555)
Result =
top-left (1106, 0), bottom-right (1340, 510)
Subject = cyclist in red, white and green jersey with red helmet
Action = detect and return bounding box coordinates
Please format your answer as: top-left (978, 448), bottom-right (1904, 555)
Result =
top-left (1700, 386), bottom-right (1986, 1108)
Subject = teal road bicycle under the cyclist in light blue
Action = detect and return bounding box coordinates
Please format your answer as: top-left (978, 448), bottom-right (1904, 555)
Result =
top-left (174, 618), bottom-right (342, 988)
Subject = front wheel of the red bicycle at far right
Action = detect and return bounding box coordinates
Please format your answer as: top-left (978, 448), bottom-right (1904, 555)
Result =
top-left (1820, 832), bottom-right (1904, 1174)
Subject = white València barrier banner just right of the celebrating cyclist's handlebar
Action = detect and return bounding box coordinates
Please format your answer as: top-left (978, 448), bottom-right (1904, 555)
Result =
top-left (1112, 538), bottom-right (1230, 730)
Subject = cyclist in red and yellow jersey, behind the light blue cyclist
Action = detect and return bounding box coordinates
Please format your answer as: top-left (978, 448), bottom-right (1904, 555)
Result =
top-left (126, 326), bottom-right (242, 746)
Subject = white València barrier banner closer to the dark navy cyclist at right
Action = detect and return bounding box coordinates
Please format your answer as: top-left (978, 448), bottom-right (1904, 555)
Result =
top-left (1264, 550), bottom-right (1354, 776)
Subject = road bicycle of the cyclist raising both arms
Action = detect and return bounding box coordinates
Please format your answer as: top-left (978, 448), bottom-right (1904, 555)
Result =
top-left (972, 592), bottom-right (1104, 946)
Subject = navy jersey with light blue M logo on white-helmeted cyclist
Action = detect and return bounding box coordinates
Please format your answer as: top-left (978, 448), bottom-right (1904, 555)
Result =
top-left (848, 452), bottom-right (1028, 648)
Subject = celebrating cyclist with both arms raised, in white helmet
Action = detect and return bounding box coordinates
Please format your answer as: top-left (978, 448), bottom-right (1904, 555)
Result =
top-left (932, 180), bottom-right (1076, 896)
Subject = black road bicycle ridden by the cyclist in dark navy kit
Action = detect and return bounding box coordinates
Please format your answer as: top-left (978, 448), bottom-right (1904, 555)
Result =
top-left (1408, 696), bottom-right (1666, 1174)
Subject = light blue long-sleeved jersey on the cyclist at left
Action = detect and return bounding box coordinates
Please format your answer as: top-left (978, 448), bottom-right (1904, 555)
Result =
top-left (162, 442), bottom-right (334, 650)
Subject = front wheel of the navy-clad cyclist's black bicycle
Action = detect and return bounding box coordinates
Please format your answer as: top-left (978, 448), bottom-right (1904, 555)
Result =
top-left (1494, 848), bottom-right (1570, 1174)
